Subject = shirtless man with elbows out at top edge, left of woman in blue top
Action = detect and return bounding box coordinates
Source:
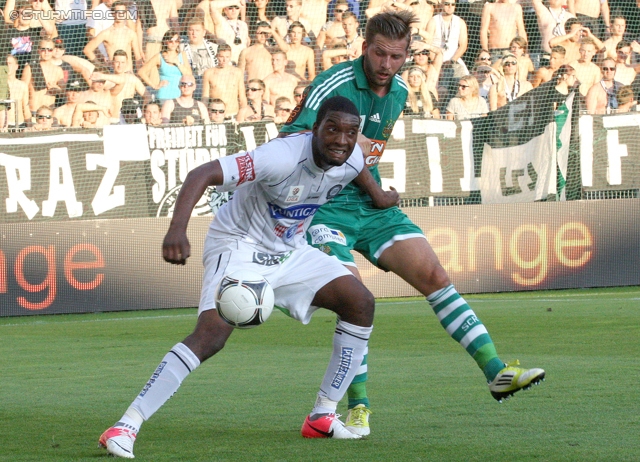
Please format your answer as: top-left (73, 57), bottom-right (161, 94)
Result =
top-left (84, 1), bottom-right (145, 70)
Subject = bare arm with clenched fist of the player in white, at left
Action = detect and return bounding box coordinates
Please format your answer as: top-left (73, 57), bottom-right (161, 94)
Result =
top-left (162, 160), bottom-right (223, 265)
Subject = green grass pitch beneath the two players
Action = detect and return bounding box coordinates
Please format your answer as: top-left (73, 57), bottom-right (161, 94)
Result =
top-left (0, 287), bottom-right (640, 462)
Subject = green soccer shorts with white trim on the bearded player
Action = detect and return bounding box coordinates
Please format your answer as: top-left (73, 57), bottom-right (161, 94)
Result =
top-left (307, 202), bottom-right (424, 269)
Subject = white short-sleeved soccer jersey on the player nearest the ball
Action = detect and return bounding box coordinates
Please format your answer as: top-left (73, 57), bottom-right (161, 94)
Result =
top-left (209, 133), bottom-right (364, 253)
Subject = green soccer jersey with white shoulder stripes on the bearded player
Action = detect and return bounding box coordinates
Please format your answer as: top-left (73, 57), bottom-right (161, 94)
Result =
top-left (280, 56), bottom-right (408, 203)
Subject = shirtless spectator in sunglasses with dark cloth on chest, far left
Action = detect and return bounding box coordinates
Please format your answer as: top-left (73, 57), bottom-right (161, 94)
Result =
top-left (21, 39), bottom-right (64, 112)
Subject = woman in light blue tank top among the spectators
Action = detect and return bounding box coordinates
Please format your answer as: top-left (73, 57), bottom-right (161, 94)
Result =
top-left (138, 29), bottom-right (191, 104)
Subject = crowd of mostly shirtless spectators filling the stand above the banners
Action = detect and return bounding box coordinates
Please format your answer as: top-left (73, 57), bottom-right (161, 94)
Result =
top-left (0, 0), bottom-right (640, 131)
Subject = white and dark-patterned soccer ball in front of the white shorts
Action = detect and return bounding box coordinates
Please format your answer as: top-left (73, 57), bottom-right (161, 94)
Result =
top-left (216, 270), bottom-right (274, 329)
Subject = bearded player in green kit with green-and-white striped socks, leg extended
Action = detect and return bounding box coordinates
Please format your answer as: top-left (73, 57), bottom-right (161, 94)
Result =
top-left (280, 11), bottom-right (545, 435)
